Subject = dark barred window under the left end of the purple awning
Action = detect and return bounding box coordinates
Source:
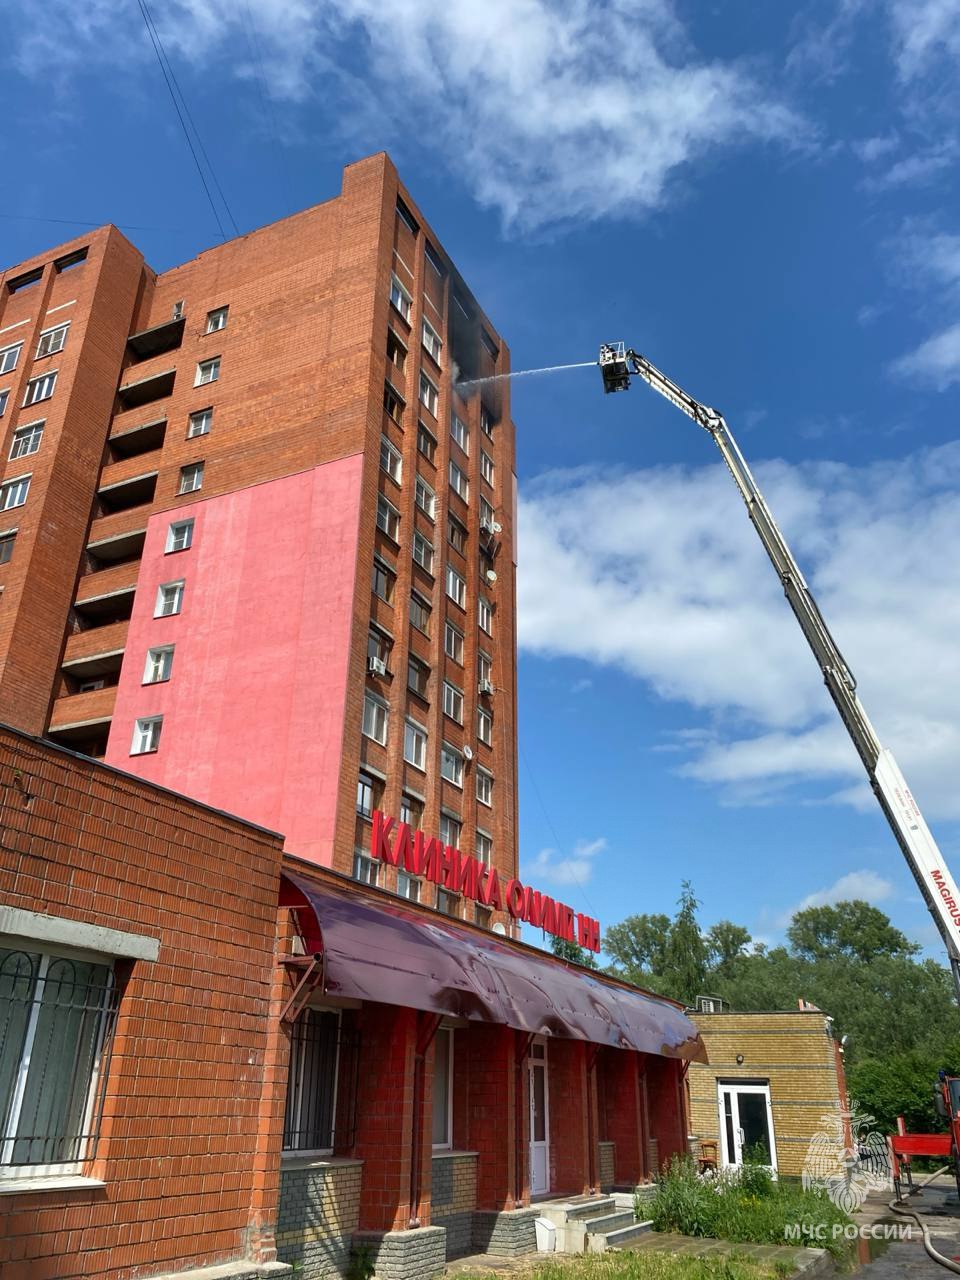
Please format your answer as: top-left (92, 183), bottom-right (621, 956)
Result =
top-left (283, 1008), bottom-right (343, 1155)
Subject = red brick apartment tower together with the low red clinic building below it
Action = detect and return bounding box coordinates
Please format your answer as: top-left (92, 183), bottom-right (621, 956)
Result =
top-left (0, 155), bottom-right (703, 1280)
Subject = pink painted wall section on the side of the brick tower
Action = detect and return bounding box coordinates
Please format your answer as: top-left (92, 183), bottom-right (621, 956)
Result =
top-left (106, 454), bottom-right (364, 865)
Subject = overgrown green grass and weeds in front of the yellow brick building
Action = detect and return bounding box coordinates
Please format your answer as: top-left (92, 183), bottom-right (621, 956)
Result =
top-left (647, 1157), bottom-right (852, 1263)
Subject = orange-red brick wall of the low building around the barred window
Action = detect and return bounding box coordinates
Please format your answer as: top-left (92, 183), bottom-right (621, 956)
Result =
top-left (0, 727), bottom-right (285, 1280)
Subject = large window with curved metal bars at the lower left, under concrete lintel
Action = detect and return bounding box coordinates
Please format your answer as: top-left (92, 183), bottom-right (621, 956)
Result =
top-left (0, 947), bottom-right (116, 1172)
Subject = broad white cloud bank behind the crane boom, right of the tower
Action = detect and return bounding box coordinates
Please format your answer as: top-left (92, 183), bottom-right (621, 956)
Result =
top-left (518, 442), bottom-right (960, 818)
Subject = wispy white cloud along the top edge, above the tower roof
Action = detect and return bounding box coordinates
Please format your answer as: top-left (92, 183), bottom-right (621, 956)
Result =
top-left (13, 0), bottom-right (808, 229)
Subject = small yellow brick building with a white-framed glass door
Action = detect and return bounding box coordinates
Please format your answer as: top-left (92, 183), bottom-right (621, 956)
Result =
top-left (687, 1010), bottom-right (846, 1178)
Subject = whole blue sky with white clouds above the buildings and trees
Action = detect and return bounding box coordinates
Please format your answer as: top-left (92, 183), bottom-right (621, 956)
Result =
top-left (0, 0), bottom-right (960, 955)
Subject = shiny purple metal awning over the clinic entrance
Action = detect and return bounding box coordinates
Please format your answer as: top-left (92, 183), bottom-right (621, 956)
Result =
top-left (284, 872), bottom-right (707, 1062)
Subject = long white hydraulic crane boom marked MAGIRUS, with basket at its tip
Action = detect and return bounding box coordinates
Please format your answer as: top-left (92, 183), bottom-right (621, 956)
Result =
top-left (599, 343), bottom-right (960, 1000)
